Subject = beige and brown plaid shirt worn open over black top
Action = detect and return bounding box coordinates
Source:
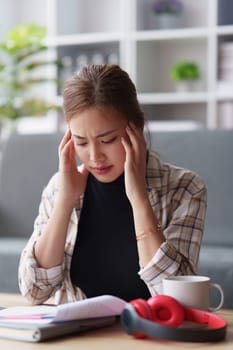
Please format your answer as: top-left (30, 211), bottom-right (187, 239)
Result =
top-left (19, 152), bottom-right (206, 304)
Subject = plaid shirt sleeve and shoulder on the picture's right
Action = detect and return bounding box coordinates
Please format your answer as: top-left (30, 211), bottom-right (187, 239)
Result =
top-left (139, 154), bottom-right (207, 295)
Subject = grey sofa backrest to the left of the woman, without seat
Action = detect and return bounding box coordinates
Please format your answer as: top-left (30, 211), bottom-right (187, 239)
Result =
top-left (0, 134), bottom-right (61, 237)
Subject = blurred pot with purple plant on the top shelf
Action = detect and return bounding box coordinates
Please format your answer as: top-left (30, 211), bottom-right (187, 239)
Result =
top-left (152, 0), bottom-right (183, 29)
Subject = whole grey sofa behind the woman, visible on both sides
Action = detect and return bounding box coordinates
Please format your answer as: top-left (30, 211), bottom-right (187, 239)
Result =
top-left (0, 129), bottom-right (233, 308)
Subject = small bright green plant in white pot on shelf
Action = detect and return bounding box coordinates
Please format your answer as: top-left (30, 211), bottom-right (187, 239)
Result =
top-left (170, 61), bottom-right (201, 92)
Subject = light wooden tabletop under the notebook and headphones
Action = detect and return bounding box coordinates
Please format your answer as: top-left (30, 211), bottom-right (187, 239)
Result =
top-left (0, 293), bottom-right (233, 350)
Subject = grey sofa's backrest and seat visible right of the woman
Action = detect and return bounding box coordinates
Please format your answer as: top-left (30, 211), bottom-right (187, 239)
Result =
top-left (150, 129), bottom-right (233, 308)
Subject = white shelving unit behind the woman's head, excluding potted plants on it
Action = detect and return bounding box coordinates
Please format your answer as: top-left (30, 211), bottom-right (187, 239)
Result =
top-left (4, 0), bottom-right (233, 128)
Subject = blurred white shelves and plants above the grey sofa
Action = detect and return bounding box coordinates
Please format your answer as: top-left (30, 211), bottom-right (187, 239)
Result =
top-left (0, 0), bottom-right (233, 133)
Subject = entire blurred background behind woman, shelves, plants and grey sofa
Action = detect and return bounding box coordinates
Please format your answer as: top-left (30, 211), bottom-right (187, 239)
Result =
top-left (0, 0), bottom-right (233, 300)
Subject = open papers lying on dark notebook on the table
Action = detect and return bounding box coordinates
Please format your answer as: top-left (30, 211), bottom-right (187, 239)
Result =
top-left (0, 295), bottom-right (126, 342)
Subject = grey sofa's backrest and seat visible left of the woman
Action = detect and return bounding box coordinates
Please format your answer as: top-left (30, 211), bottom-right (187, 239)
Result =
top-left (0, 133), bottom-right (61, 292)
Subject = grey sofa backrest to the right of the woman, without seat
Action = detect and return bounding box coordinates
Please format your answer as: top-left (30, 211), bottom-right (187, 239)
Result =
top-left (150, 129), bottom-right (233, 246)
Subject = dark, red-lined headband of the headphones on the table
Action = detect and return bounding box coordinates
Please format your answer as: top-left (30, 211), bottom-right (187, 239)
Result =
top-left (121, 303), bottom-right (227, 342)
